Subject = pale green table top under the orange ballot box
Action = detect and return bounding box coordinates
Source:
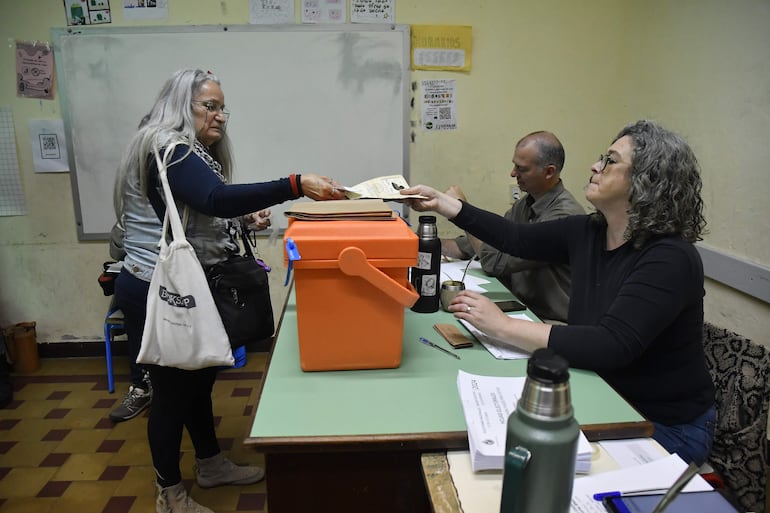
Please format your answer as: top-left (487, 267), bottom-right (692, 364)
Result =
top-left (245, 268), bottom-right (650, 450)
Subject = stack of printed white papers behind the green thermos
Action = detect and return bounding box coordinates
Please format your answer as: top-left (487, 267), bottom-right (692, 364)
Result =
top-left (457, 371), bottom-right (591, 474)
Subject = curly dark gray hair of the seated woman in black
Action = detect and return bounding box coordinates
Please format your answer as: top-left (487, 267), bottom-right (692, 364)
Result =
top-left (599, 120), bottom-right (706, 249)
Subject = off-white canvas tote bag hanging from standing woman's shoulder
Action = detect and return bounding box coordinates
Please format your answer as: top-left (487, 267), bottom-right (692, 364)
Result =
top-left (136, 146), bottom-right (235, 370)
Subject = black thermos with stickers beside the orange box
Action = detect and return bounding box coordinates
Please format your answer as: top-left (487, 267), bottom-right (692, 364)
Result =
top-left (410, 216), bottom-right (441, 313)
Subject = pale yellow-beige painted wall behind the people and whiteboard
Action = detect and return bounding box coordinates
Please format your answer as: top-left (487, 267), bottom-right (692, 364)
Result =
top-left (0, 0), bottom-right (770, 344)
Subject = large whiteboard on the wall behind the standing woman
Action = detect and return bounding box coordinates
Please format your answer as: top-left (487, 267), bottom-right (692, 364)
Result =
top-left (52, 25), bottom-right (410, 240)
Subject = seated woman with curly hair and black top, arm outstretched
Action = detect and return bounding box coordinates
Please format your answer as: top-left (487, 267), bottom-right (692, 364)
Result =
top-left (402, 120), bottom-right (716, 463)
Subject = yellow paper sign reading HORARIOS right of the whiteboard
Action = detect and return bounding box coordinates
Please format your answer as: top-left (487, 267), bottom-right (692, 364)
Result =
top-left (412, 25), bottom-right (472, 71)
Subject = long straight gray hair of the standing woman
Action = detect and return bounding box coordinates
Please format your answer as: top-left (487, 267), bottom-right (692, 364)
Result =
top-left (113, 69), bottom-right (232, 219)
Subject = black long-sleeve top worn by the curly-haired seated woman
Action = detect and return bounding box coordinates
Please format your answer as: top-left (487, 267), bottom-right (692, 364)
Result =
top-left (452, 203), bottom-right (714, 425)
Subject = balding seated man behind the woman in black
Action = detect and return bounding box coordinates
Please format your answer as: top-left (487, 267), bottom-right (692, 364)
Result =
top-left (441, 131), bottom-right (585, 322)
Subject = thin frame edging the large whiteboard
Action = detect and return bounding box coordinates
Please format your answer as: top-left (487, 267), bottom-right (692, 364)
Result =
top-left (51, 23), bottom-right (412, 241)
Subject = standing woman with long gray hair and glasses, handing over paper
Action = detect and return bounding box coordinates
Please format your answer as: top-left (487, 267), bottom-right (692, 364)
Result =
top-left (114, 69), bottom-right (344, 513)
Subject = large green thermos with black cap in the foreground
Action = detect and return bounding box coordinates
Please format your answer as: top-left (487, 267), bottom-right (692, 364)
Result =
top-left (500, 348), bottom-right (580, 513)
